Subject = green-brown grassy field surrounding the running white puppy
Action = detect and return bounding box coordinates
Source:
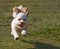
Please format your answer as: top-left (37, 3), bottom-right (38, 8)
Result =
top-left (0, 0), bottom-right (60, 49)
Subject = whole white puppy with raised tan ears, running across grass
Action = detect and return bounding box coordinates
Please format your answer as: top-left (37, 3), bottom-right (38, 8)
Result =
top-left (11, 4), bottom-right (28, 40)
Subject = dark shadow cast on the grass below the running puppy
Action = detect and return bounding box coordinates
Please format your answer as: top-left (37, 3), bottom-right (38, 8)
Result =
top-left (22, 40), bottom-right (60, 49)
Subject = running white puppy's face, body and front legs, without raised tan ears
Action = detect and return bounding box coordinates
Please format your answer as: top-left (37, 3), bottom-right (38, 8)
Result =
top-left (11, 13), bottom-right (27, 40)
